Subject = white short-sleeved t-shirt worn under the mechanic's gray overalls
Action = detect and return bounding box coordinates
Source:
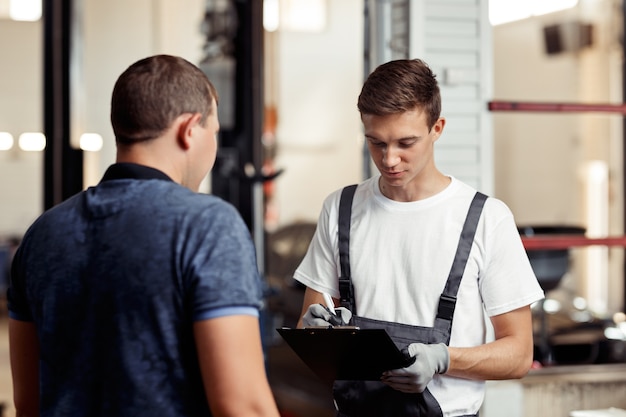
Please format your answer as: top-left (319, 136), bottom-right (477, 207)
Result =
top-left (294, 175), bottom-right (543, 416)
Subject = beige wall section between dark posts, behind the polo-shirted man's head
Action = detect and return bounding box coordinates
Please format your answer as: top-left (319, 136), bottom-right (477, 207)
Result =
top-left (83, 0), bottom-right (205, 185)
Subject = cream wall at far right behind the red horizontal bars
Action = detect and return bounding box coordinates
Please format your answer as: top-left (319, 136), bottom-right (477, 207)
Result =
top-left (493, 0), bottom-right (624, 312)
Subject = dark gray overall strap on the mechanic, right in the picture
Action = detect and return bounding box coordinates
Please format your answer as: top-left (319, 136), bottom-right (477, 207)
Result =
top-left (435, 192), bottom-right (487, 344)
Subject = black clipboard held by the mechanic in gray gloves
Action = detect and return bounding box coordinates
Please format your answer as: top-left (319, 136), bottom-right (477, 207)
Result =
top-left (276, 326), bottom-right (413, 382)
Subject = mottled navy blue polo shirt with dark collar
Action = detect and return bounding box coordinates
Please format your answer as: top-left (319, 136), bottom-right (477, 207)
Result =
top-left (8, 163), bottom-right (262, 417)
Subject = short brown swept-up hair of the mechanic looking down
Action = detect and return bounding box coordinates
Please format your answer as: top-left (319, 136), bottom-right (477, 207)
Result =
top-left (357, 59), bottom-right (441, 129)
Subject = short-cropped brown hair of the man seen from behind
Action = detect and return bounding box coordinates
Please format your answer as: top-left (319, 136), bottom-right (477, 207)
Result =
top-left (111, 55), bottom-right (218, 144)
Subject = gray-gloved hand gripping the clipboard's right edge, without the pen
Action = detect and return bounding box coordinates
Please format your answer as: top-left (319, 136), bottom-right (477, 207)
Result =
top-left (381, 343), bottom-right (450, 393)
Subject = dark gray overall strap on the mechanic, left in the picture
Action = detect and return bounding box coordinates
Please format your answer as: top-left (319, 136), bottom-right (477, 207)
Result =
top-left (339, 184), bottom-right (357, 315)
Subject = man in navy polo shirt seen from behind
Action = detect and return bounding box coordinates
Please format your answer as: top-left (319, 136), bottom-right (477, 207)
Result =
top-left (8, 55), bottom-right (279, 417)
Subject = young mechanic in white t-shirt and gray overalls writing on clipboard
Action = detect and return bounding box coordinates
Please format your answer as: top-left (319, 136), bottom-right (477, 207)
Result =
top-left (294, 59), bottom-right (543, 417)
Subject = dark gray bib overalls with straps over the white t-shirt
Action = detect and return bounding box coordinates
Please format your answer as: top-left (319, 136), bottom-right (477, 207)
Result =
top-left (333, 185), bottom-right (487, 417)
